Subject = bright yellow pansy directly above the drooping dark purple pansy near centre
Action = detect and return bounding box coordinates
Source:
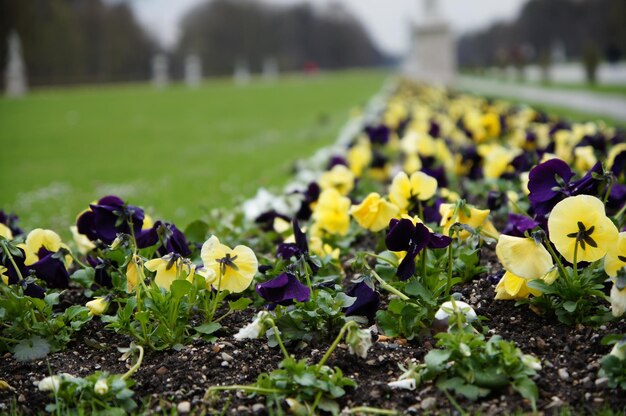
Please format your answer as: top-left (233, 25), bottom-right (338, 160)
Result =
top-left (389, 172), bottom-right (437, 212)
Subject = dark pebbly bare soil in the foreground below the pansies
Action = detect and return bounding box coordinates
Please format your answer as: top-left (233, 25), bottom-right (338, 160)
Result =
top-left (0, 245), bottom-right (626, 415)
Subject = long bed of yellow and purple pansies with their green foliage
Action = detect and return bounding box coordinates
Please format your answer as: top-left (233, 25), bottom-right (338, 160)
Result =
top-left (0, 82), bottom-right (626, 412)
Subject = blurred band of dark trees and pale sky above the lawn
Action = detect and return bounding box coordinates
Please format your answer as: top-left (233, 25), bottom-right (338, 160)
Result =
top-left (0, 0), bottom-right (626, 86)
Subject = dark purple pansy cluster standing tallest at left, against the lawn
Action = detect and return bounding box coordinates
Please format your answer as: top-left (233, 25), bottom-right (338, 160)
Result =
top-left (76, 195), bottom-right (144, 244)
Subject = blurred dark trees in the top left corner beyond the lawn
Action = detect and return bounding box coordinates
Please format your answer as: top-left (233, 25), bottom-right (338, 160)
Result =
top-left (0, 0), bottom-right (157, 85)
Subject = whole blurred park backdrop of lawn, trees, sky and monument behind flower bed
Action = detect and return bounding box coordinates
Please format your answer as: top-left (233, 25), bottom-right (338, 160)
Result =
top-left (0, 0), bottom-right (626, 235)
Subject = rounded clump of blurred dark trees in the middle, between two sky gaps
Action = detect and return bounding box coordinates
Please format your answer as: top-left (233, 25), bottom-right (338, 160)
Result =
top-left (176, 0), bottom-right (383, 75)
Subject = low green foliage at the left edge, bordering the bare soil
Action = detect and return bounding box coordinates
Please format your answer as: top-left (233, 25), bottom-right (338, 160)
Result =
top-left (0, 283), bottom-right (91, 361)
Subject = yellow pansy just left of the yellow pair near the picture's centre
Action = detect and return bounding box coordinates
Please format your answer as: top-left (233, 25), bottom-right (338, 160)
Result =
top-left (313, 188), bottom-right (351, 235)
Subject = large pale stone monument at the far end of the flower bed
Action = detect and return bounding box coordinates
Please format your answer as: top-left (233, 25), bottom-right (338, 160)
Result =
top-left (404, 0), bottom-right (457, 85)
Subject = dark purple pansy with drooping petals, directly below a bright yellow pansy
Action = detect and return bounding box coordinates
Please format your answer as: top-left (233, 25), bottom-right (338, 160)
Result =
top-left (385, 218), bottom-right (452, 280)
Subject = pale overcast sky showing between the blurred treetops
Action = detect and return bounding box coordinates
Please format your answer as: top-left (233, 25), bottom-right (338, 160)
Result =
top-left (131, 0), bottom-right (526, 54)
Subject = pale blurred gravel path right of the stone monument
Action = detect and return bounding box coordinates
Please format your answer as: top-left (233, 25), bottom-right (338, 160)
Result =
top-left (456, 76), bottom-right (626, 121)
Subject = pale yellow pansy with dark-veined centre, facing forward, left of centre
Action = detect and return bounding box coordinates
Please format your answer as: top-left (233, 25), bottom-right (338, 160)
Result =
top-left (200, 236), bottom-right (259, 293)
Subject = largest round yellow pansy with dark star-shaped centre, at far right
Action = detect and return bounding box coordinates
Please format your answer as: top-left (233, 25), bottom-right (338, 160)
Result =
top-left (548, 195), bottom-right (619, 263)
